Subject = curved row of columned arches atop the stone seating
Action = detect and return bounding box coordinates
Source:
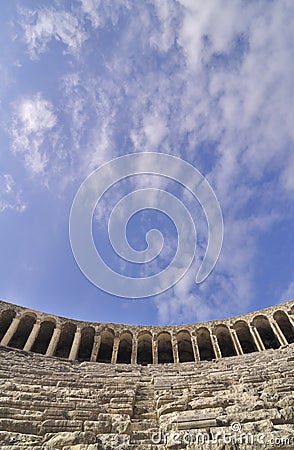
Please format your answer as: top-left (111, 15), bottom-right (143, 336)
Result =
top-left (0, 306), bottom-right (294, 365)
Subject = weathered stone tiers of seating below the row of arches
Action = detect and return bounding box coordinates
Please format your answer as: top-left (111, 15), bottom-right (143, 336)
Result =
top-left (0, 344), bottom-right (294, 450)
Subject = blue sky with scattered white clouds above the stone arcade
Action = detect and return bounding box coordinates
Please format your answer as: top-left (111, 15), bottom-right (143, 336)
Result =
top-left (0, 0), bottom-right (294, 324)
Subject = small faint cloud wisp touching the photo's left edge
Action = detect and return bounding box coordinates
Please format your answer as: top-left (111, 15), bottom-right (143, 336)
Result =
top-left (0, 174), bottom-right (27, 213)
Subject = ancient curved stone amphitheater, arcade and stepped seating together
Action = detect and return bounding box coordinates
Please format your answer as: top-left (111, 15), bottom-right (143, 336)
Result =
top-left (0, 301), bottom-right (294, 450)
